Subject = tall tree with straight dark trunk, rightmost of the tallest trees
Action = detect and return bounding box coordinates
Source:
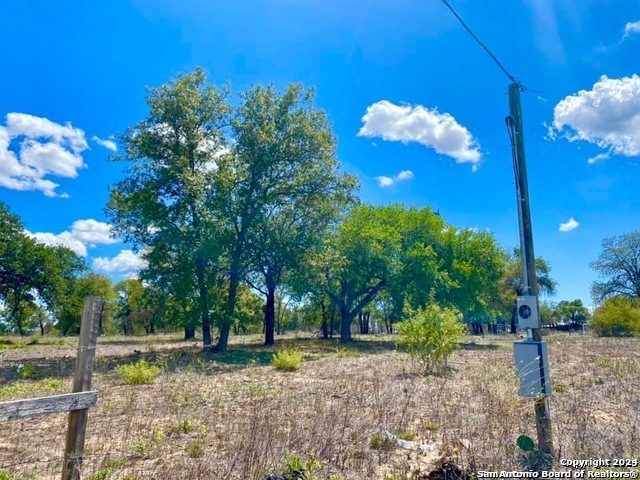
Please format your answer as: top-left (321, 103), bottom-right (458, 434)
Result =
top-left (235, 84), bottom-right (356, 345)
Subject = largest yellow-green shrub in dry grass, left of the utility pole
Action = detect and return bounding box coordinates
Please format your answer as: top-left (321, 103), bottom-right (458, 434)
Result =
top-left (397, 303), bottom-right (466, 373)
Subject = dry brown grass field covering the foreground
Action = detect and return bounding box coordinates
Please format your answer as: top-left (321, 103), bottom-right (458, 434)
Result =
top-left (0, 334), bottom-right (640, 480)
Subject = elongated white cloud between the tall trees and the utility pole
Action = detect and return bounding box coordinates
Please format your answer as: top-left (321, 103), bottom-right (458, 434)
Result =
top-left (358, 100), bottom-right (480, 166)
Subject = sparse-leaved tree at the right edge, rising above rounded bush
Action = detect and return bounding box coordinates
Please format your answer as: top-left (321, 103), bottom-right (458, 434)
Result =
top-left (591, 231), bottom-right (640, 302)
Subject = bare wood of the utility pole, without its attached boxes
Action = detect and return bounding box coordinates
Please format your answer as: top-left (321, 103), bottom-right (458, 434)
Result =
top-left (508, 82), bottom-right (553, 455)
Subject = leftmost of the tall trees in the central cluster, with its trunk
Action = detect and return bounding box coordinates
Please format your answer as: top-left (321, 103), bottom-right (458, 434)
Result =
top-left (106, 69), bottom-right (230, 348)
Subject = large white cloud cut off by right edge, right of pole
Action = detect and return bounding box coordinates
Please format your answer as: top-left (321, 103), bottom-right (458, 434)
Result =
top-left (553, 74), bottom-right (640, 160)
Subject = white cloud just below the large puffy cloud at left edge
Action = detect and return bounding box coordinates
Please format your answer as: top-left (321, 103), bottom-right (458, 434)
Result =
top-left (26, 218), bottom-right (117, 257)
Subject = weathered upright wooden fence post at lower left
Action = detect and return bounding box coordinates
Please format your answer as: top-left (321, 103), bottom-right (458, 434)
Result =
top-left (62, 297), bottom-right (104, 480)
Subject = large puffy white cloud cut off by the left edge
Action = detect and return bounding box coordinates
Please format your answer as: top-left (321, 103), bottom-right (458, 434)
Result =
top-left (0, 113), bottom-right (89, 198)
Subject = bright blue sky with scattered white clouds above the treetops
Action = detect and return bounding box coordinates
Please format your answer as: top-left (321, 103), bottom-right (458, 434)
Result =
top-left (0, 0), bottom-right (640, 304)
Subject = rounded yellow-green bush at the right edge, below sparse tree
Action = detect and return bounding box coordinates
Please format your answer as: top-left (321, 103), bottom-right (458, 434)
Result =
top-left (590, 297), bottom-right (640, 337)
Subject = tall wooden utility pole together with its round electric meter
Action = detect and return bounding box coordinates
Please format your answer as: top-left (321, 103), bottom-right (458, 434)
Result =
top-left (507, 82), bottom-right (553, 456)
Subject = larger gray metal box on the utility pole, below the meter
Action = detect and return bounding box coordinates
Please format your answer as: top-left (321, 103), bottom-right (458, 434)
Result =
top-left (513, 340), bottom-right (551, 397)
